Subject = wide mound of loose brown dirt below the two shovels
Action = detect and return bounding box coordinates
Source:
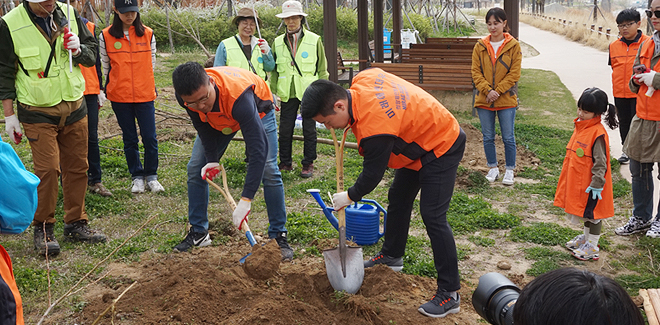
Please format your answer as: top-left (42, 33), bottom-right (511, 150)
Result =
top-left (77, 244), bottom-right (479, 325)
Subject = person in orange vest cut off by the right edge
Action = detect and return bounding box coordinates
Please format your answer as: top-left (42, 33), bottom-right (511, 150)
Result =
top-left (614, 0), bottom-right (660, 238)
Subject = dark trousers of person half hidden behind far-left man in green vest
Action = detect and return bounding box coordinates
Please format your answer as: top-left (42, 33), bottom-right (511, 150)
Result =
top-left (85, 94), bottom-right (101, 185)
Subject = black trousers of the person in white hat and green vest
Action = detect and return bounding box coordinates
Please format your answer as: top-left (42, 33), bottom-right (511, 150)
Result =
top-left (279, 98), bottom-right (316, 166)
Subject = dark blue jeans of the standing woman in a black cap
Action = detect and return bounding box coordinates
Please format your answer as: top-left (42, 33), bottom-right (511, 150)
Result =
top-left (111, 101), bottom-right (158, 181)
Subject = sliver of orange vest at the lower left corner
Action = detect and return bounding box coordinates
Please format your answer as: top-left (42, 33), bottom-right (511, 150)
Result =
top-left (0, 245), bottom-right (23, 325)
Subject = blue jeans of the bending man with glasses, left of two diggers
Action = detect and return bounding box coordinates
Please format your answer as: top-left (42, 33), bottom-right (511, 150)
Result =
top-left (188, 110), bottom-right (286, 238)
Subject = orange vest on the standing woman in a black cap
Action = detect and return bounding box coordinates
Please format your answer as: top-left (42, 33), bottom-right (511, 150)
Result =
top-left (103, 26), bottom-right (156, 103)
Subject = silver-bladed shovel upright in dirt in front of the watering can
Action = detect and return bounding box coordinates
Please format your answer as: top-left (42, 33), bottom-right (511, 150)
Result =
top-left (323, 130), bottom-right (364, 294)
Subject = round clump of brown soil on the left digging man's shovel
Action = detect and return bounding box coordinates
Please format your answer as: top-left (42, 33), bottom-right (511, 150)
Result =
top-left (243, 239), bottom-right (282, 280)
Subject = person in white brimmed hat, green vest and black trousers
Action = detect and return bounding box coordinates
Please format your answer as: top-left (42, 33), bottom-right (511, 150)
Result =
top-left (270, 0), bottom-right (328, 178)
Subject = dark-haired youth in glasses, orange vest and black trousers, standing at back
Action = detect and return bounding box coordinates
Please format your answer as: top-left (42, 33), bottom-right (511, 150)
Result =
top-left (608, 9), bottom-right (649, 164)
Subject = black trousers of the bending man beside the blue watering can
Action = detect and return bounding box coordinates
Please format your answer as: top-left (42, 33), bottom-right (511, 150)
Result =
top-left (382, 130), bottom-right (465, 291)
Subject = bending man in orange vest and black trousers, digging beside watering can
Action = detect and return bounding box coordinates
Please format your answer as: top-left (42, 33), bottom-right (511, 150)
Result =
top-left (301, 69), bottom-right (465, 317)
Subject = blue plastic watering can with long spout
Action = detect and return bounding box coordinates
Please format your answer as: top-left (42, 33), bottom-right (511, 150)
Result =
top-left (307, 189), bottom-right (387, 245)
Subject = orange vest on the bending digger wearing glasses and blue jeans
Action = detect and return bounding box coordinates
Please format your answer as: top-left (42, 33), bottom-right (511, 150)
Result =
top-left (188, 66), bottom-right (273, 134)
